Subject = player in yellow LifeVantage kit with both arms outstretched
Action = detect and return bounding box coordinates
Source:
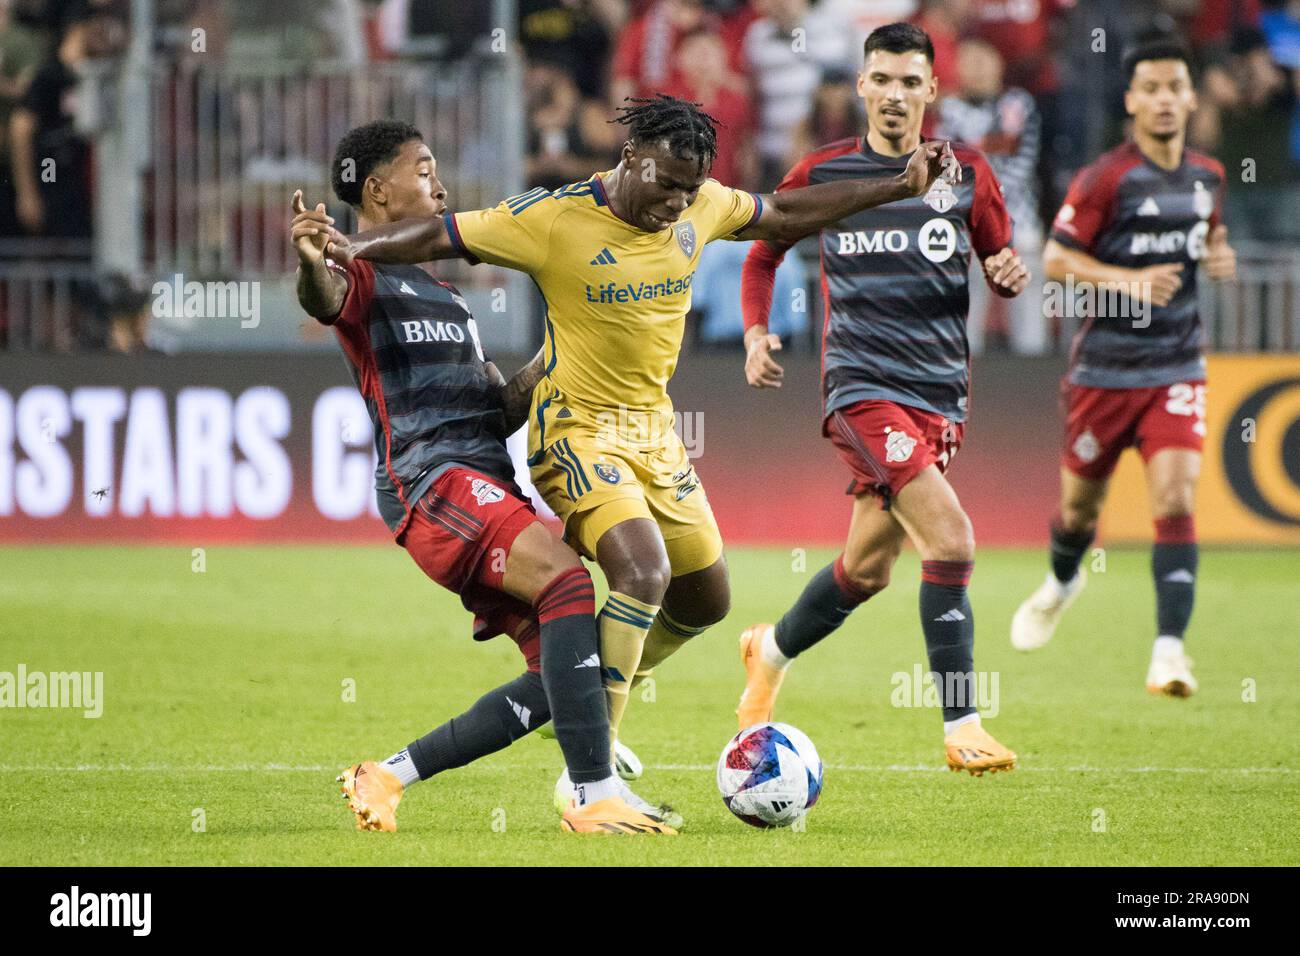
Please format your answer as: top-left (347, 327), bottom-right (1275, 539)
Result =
top-left (322, 94), bottom-right (956, 806)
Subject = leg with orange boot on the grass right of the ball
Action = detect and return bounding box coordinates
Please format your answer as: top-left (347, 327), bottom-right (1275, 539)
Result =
top-left (893, 464), bottom-right (1015, 775)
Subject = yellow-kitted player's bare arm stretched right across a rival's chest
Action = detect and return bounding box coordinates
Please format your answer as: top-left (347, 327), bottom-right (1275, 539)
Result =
top-left (736, 142), bottom-right (961, 242)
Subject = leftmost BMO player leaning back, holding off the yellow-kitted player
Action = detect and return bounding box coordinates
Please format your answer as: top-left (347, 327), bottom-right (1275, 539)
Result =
top-left (291, 121), bottom-right (675, 834)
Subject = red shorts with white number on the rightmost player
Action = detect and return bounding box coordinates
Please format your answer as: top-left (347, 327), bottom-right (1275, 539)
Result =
top-left (1061, 380), bottom-right (1205, 481)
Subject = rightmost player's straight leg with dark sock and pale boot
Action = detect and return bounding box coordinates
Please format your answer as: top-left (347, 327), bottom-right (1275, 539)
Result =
top-left (1147, 447), bottom-right (1201, 697)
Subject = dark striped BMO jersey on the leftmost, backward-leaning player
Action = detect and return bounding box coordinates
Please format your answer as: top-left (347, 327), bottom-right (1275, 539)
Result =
top-left (326, 259), bottom-right (515, 535)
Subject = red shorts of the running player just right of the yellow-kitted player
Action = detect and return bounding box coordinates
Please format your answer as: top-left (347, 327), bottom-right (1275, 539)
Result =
top-left (824, 398), bottom-right (966, 507)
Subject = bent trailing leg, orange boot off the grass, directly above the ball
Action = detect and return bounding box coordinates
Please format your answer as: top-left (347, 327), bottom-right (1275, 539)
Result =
top-left (736, 493), bottom-right (904, 730)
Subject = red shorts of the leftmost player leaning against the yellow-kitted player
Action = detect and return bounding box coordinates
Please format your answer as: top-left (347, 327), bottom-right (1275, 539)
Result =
top-left (398, 468), bottom-right (541, 670)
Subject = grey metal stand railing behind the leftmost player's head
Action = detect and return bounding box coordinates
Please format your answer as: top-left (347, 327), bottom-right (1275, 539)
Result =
top-left (146, 55), bottom-right (530, 351)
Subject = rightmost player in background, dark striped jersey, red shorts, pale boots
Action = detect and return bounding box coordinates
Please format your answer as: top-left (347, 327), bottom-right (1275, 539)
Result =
top-left (1011, 39), bottom-right (1236, 697)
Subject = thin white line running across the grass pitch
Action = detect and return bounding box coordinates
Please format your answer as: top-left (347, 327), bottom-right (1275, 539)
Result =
top-left (0, 763), bottom-right (1300, 774)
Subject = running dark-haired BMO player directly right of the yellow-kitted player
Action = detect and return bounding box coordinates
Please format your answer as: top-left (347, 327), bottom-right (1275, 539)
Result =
top-left (736, 23), bottom-right (1030, 775)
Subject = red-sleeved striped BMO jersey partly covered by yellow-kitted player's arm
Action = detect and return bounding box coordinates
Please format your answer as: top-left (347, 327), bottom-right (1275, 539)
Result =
top-left (742, 138), bottom-right (1011, 421)
